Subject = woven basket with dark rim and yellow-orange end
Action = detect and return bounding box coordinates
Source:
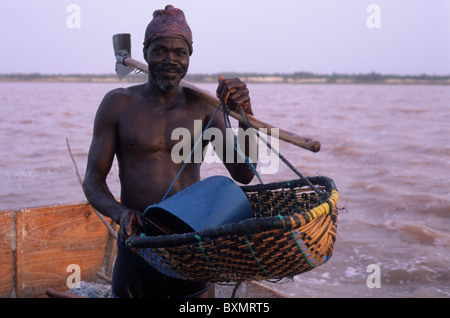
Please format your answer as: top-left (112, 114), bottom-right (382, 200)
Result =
top-left (126, 177), bottom-right (338, 282)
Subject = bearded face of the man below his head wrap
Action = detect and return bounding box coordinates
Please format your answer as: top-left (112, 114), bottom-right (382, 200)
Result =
top-left (147, 38), bottom-right (189, 91)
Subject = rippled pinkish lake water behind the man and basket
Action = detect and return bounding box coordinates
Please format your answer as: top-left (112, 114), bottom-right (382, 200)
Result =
top-left (0, 83), bottom-right (450, 297)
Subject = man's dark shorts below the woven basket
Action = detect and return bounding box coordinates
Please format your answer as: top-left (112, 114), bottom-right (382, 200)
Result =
top-left (112, 243), bottom-right (211, 298)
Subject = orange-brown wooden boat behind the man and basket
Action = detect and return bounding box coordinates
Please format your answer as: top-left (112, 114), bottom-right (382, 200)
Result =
top-left (0, 203), bottom-right (284, 298)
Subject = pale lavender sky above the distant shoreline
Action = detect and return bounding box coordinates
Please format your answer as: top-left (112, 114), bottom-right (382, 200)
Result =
top-left (0, 0), bottom-right (450, 75)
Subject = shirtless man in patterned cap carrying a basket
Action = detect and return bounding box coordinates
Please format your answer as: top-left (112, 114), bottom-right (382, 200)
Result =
top-left (83, 6), bottom-right (254, 297)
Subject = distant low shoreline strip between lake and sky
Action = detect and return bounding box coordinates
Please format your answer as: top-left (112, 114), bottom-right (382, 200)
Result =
top-left (0, 72), bottom-right (450, 85)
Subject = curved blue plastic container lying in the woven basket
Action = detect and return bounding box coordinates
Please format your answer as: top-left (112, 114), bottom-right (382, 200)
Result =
top-left (144, 176), bottom-right (253, 235)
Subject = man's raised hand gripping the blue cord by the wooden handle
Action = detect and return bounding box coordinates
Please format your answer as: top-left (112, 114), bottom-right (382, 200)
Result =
top-left (217, 76), bottom-right (253, 115)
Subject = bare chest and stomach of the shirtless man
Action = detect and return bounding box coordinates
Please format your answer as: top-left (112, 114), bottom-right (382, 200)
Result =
top-left (111, 85), bottom-right (212, 211)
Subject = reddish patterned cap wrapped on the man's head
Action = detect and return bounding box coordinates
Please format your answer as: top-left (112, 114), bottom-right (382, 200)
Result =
top-left (144, 5), bottom-right (193, 57)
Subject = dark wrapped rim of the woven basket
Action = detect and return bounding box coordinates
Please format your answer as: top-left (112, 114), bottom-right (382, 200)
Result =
top-left (125, 176), bottom-right (337, 248)
